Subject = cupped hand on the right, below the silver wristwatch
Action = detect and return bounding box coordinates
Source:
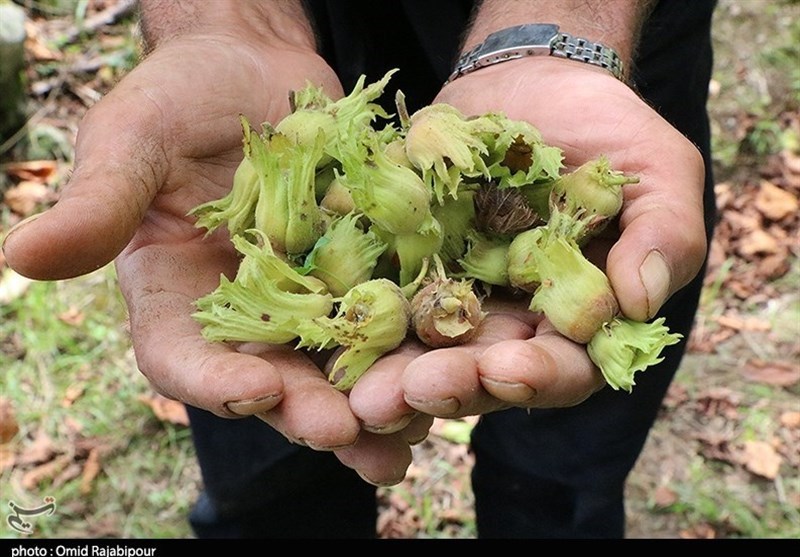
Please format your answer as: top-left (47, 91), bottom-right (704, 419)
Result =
top-left (350, 58), bottom-right (706, 424)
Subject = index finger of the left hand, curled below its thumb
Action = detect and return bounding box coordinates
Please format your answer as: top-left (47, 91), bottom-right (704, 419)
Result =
top-left (117, 244), bottom-right (283, 417)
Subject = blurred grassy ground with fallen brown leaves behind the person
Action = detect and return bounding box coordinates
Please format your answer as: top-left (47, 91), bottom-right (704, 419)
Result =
top-left (0, 0), bottom-right (800, 538)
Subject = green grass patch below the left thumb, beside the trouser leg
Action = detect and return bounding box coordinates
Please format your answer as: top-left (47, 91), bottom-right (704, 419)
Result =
top-left (0, 266), bottom-right (199, 537)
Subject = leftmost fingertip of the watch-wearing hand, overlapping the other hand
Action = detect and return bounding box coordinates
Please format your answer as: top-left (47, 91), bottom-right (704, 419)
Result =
top-left (349, 342), bottom-right (425, 435)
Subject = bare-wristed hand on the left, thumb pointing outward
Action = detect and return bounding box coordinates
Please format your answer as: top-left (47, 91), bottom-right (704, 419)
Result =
top-left (4, 34), bottom-right (431, 483)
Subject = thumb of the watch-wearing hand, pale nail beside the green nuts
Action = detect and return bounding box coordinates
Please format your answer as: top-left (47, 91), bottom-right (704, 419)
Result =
top-left (606, 138), bottom-right (707, 321)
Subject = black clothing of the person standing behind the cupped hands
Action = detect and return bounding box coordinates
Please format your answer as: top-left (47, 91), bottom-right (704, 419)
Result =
top-left (190, 0), bottom-right (714, 538)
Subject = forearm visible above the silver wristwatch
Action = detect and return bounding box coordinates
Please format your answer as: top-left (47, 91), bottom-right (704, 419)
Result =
top-left (463, 0), bottom-right (655, 65)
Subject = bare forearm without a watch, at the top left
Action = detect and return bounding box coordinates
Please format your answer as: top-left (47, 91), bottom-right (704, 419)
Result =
top-left (139, 0), bottom-right (315, 51)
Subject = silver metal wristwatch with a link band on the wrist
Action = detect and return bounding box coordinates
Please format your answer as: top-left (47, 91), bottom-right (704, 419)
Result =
top-left (447, 23), bottom-right (624, 83)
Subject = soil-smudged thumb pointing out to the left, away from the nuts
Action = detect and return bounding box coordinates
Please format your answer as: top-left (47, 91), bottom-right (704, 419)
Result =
top-left (3, 87), bottom-right (167, 280)
